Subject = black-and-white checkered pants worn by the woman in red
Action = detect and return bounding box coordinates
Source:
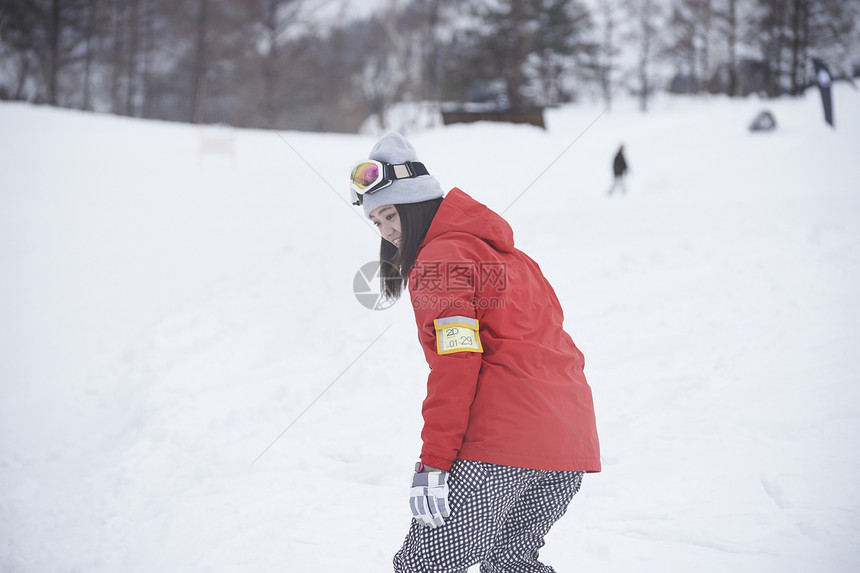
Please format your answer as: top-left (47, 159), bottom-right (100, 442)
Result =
top-left (394, 460), bottom-right (584, 573)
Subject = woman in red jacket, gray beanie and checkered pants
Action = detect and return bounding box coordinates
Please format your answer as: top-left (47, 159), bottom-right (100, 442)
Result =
top-left (351, 133), bottom-right (600, 573)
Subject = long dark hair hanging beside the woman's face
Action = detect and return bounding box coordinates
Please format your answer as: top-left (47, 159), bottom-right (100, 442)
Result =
top-left (379, 197), bottom-right (442, 300)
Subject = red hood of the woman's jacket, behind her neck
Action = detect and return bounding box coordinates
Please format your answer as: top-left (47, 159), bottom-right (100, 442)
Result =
top-left (421, 187), bottom-right (514, 252)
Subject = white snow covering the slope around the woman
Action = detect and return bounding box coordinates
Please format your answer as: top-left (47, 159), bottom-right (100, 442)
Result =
top-left (0, 85), bottom-right (860, 573)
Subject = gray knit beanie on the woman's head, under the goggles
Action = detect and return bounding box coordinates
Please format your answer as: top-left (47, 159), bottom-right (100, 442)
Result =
top-left (354, 131), bottom-right (443, 217)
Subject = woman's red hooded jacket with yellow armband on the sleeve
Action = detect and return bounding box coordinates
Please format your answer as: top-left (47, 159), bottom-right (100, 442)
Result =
top-left (409, 188), bottom-right (600, 472)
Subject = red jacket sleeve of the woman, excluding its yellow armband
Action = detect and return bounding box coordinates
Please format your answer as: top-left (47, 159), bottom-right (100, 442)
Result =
top-left (409, 240), bottom-right (483, 470)
